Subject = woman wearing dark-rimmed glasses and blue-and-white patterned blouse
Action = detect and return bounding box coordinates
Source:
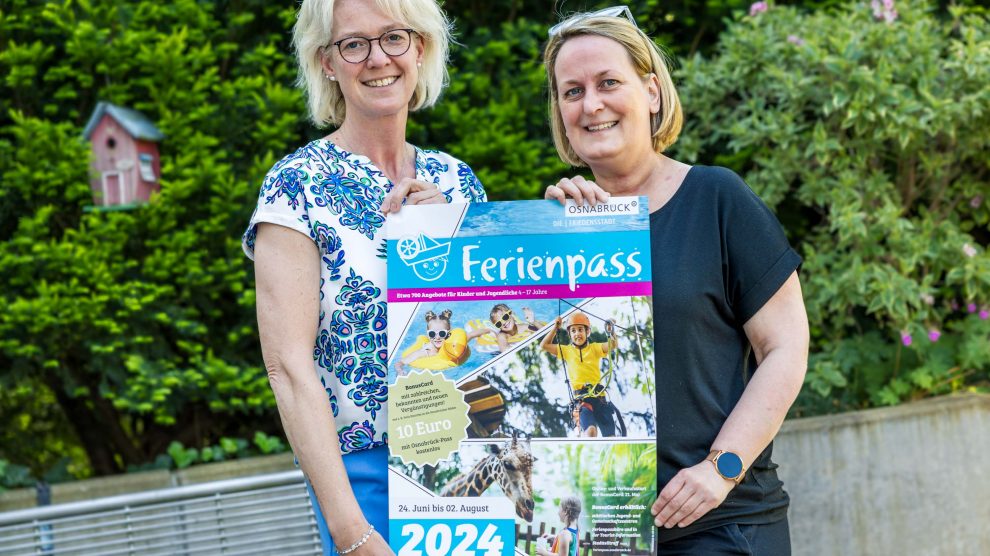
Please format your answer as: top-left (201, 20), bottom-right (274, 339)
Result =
top-left (243, 0), bottom-right (485, 556)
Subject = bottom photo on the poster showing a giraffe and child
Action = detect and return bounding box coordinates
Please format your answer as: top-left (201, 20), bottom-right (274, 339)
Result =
top-left (389, 437), bottom-right (656, 556)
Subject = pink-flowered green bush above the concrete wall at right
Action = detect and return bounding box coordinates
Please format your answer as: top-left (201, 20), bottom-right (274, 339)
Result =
top-left (677, 1), bottom-right (990, 413)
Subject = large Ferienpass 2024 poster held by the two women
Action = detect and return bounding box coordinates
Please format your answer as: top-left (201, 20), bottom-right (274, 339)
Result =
top-left (386, 197), bottom-right (656, 556)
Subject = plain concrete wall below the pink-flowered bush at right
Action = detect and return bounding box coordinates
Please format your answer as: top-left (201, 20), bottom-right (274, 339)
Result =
top-left (774, 394), bottom-right (990, 556)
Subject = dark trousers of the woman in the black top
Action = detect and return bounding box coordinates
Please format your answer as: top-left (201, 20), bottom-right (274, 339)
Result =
top-left (657, 518), bottom-right (791, 556)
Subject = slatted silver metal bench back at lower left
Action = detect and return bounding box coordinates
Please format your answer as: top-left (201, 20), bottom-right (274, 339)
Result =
top-left (0, 470), bottom-right (322, 556)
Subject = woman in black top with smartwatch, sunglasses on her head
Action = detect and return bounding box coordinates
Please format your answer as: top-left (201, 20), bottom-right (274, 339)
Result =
top-left (544, 7), bottom-right (808, 556)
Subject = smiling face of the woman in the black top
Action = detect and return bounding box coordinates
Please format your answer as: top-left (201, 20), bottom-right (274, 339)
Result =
top-left (554, 35), bottom-right (660, 166)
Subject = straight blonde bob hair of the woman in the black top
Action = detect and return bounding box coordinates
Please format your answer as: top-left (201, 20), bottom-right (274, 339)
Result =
top-left (543, 14), bottom-right (684, 166)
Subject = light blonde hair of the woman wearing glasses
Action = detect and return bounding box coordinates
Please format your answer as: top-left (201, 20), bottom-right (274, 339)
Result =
top-left (292, 0), bottom-right (450, 127)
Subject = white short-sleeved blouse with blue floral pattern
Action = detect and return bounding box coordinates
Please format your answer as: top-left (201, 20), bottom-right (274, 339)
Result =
top-left (242, 139), bottom-right (486, 453)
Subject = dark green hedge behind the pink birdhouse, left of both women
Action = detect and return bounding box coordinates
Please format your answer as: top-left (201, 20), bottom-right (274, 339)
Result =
top-left (0, 0), bottom-right (302, 477)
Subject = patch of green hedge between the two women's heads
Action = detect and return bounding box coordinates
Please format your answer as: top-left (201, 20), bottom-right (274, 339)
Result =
top-left (410, 19), bottom-right (567, 200)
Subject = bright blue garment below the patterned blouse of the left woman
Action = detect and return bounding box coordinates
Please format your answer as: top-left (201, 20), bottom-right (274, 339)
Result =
top-left (306, 446), bottom-right (388, 556)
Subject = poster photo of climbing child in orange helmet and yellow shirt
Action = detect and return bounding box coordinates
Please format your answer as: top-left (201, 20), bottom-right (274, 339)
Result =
top-left (459, 296), bottom-right (656, 439)
